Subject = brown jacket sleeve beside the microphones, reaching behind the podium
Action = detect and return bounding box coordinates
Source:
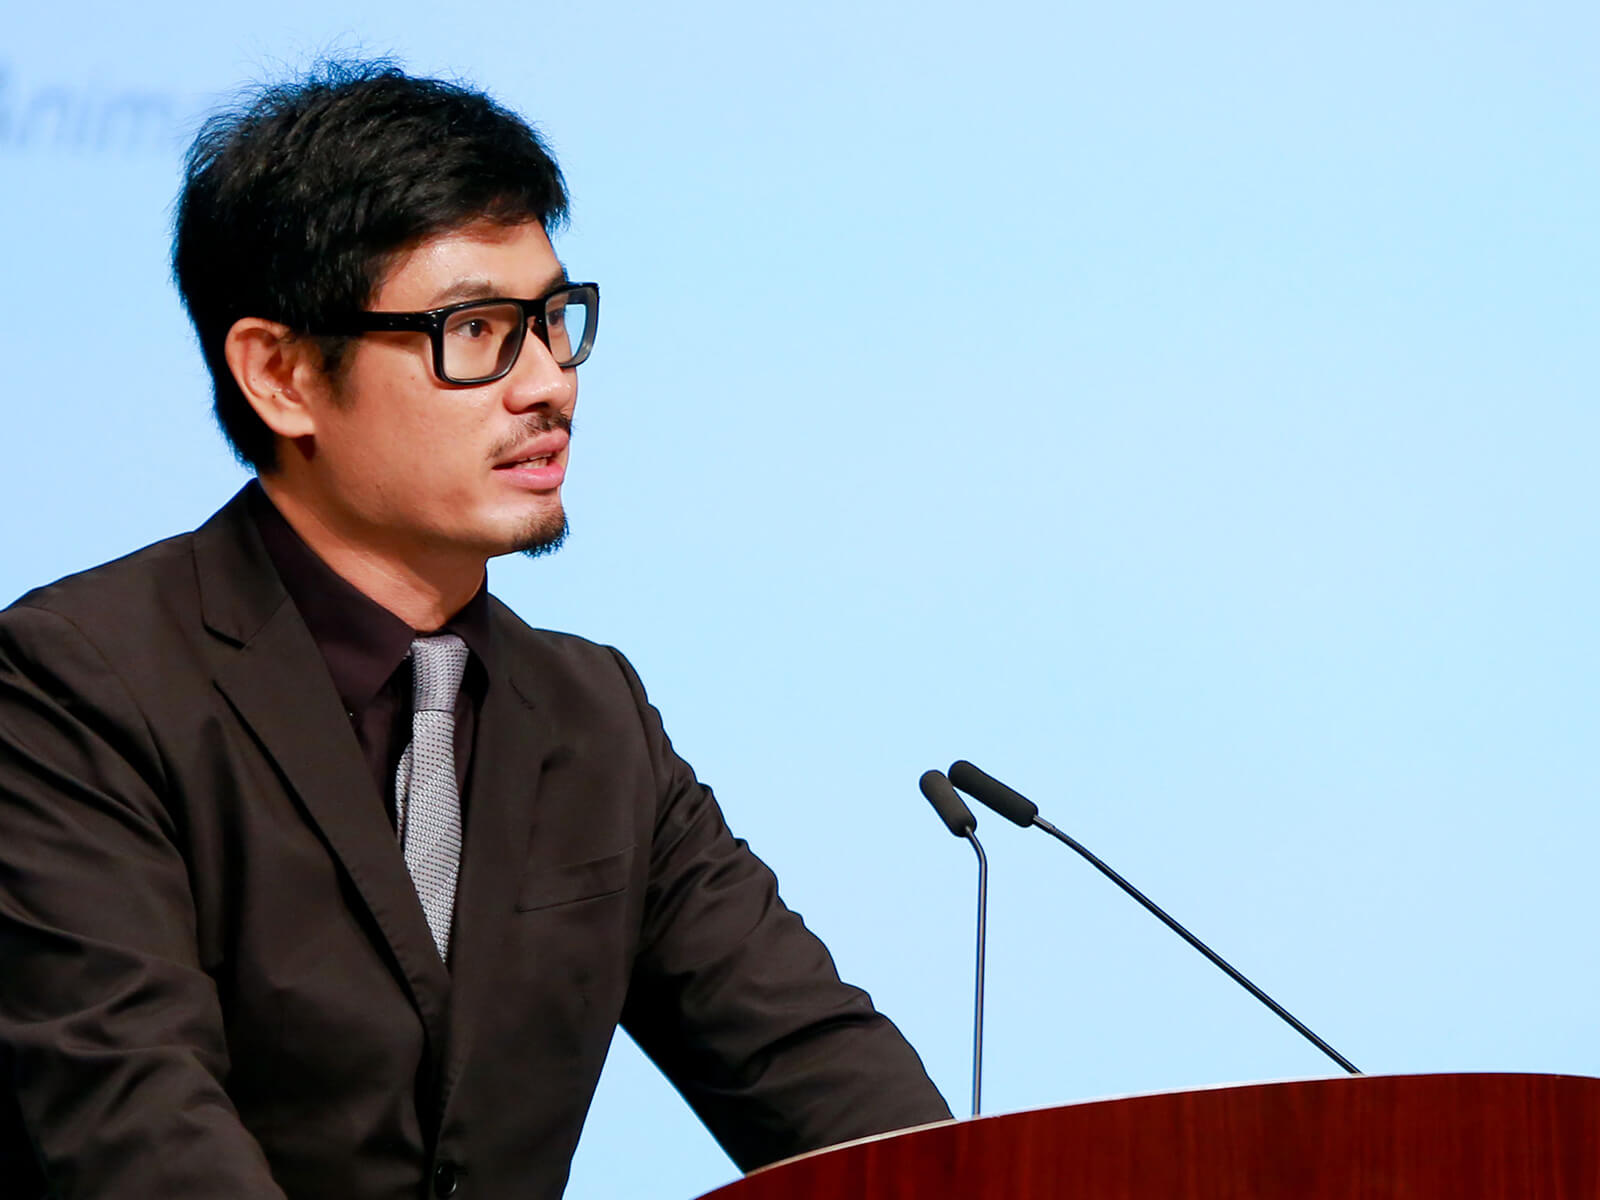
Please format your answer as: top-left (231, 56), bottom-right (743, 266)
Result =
top-left (604, 656), bottom-right (950, 1171)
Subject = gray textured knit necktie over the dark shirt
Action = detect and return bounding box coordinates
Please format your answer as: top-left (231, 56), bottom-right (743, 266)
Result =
top-left (395, 634), bottom-right (467, 962)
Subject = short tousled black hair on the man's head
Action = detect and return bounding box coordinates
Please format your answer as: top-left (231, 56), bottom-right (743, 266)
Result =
top-left (173, 61), bottom-right (566, 472)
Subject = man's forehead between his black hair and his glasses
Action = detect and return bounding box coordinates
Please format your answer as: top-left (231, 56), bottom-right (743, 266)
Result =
top-left (373, 221), bottom-right (565, 312)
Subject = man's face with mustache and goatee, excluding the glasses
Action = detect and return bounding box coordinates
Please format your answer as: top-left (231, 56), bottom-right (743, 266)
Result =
top-left (297, 222), bottom-right (578, 558)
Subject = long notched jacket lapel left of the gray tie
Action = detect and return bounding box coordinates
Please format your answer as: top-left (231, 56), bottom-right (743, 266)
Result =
top-left (195, 493), bottom-right (450, 1069)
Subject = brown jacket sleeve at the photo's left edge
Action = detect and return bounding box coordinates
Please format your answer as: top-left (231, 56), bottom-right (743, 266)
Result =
top-left (0, 602), bottom-right (283, 1200)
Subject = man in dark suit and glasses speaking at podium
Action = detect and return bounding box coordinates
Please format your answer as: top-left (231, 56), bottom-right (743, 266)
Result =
top-left (0, 67), bottom-right (949, 1200)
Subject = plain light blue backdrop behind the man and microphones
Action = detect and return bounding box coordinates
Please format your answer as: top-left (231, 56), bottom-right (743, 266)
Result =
top-left (0, 0), bottom-right (1600, 1200)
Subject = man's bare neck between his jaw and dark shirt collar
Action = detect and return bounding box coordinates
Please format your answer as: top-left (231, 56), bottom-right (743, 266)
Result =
top-left (259, 475), bottom-right (485, 634)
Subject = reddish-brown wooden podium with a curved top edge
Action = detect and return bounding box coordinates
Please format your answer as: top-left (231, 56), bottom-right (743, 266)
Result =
top-left (702, 1075), bottom-right (1600, 1200)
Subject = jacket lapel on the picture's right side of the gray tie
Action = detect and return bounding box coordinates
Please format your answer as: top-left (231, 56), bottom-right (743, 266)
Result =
top-left (443, 611), bottom-right (558, 1106)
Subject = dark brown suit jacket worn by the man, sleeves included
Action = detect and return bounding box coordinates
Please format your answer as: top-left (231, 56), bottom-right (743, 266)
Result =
top-left (0, 498), bottom-right (947, 1200)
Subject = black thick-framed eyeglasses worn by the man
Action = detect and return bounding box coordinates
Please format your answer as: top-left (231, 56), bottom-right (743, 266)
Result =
top-left (312, 283), bottom-right (600, 384)
